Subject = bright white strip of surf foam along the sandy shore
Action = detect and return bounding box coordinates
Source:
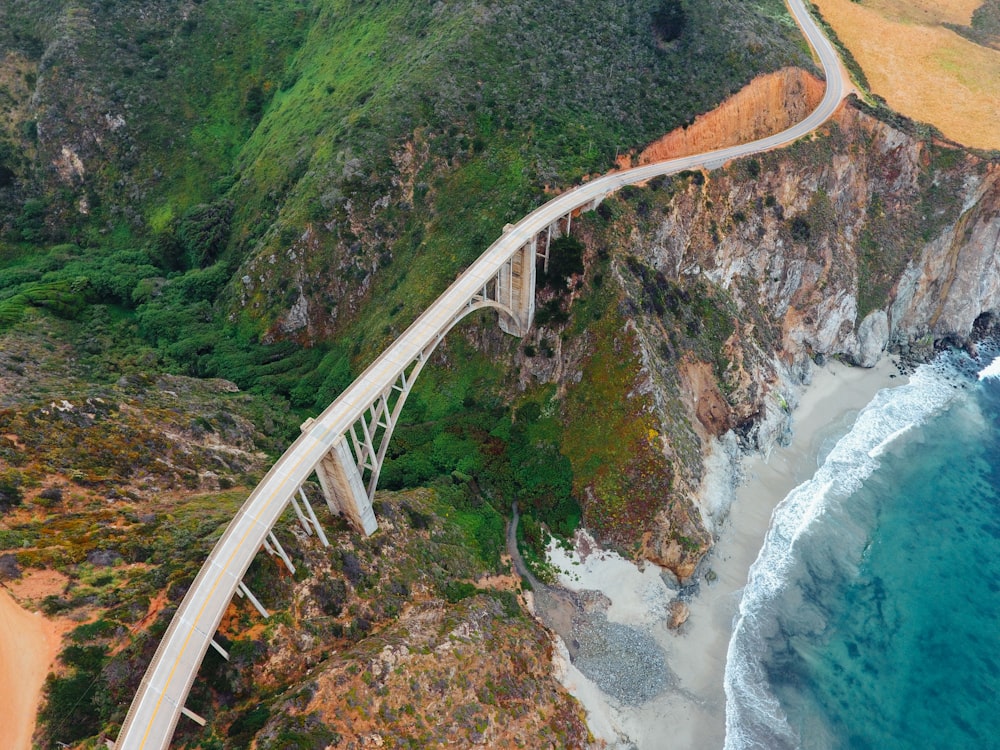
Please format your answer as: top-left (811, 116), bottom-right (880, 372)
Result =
top-left (725, 355), bottom-right (972, 750)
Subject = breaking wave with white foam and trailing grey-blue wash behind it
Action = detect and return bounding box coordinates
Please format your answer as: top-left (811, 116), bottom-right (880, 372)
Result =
top-left (725, 352), bottom-right (1000, 750)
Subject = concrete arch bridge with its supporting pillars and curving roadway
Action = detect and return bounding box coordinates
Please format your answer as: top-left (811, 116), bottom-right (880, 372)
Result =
top-left (116, 0), bottom-right (844, 750)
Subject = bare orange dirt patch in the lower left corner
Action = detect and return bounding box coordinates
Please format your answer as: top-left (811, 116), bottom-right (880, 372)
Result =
top-left (0, 588), bottom-right (63, 750)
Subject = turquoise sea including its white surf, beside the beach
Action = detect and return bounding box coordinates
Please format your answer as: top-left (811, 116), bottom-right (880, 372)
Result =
top-left (726, 354), bottom-right (1000, 750)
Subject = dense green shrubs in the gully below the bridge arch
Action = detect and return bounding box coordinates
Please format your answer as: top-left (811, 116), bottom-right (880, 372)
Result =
top-left (381, 336), bottom-right (580, 564)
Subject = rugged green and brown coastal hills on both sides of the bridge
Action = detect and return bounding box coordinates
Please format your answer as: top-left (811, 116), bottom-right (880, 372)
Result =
top-left (0, 0), bottom-right (1000, 748)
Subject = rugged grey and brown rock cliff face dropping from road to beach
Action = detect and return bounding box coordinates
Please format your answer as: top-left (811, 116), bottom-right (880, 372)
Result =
top-left (605, 94), bottom-right (1000, 556)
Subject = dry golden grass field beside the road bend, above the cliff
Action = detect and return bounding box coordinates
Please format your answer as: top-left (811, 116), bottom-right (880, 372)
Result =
top-left (814, 0), bottom-right (1000, 149)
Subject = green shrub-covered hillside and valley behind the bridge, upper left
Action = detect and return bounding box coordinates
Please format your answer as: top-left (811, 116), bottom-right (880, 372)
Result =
top-left (0, 0), bottom-right (802, 424)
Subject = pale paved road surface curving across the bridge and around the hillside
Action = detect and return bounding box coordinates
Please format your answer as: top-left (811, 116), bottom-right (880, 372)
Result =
top-left (116, 0), bottom-right (844, 750)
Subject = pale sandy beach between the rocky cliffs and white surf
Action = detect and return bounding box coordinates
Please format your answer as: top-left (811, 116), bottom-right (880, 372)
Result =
top-left (551, 358), bottom-right (906, 750)
